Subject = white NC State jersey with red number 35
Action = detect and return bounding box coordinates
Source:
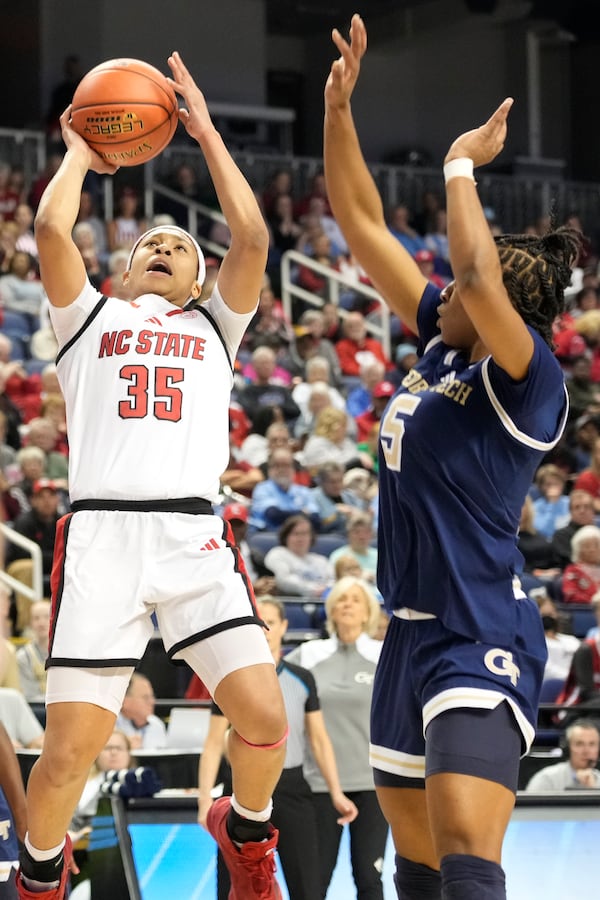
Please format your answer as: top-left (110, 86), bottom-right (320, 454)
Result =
top-left (50, 283), bottom-right (254, 502)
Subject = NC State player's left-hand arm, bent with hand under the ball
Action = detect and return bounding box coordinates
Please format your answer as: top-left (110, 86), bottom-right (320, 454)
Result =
top-left (35, 109), bottom-right (116, 306)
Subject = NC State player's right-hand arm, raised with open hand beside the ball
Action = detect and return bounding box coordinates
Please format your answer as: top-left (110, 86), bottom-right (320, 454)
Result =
top-left (169, 52), bottom-right (269, 313)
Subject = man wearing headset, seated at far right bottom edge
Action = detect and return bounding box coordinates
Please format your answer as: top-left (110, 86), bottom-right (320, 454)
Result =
top-left (525, 719), bottom-right (600, 794)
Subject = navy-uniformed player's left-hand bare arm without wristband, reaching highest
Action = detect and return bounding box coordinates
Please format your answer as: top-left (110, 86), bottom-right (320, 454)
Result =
top-left (324, 15), bottom-right (427, 332)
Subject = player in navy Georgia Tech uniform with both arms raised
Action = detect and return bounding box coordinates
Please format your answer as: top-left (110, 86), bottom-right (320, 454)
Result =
top-left (325, 15), bottom-right (580, 900)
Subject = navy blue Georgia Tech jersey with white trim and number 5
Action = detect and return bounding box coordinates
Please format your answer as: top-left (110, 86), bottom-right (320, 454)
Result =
top-left (377, 285), bottom-right (568, 644)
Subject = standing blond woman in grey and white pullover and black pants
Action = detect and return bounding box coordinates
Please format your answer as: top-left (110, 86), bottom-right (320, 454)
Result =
top-left (286, 575), bottom-right (388, 900)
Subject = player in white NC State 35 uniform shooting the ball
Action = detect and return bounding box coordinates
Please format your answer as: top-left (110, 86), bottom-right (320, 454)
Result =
top-left (18, 53), bottom-right (287, 900)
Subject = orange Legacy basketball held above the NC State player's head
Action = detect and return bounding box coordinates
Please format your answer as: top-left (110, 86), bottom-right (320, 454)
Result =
top-left (71, 59), bottom-right (179, 166)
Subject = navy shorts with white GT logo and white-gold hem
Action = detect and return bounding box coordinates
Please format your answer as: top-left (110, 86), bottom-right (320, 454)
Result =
top-left (369, 601), bottom-right (547, 786)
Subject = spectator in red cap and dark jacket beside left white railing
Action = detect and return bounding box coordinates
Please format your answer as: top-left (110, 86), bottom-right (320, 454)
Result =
top-left (6, 478), bottom-right (60, 633)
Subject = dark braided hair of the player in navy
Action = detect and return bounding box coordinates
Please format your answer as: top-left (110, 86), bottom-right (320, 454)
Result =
top-left (495, 226), bottom-right (582, 347)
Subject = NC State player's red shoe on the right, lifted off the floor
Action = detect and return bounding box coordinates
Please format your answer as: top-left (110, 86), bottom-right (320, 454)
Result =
top-left (206, 797), bottom-right (282, 900)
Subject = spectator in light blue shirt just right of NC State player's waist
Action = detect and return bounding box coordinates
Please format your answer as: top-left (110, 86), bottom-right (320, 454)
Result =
top-left (250, 447), bottom-right (321, 531)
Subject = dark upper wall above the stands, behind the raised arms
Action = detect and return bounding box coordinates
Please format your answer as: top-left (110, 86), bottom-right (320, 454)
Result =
top-left (0, 0), bottom-right (600, 179)
